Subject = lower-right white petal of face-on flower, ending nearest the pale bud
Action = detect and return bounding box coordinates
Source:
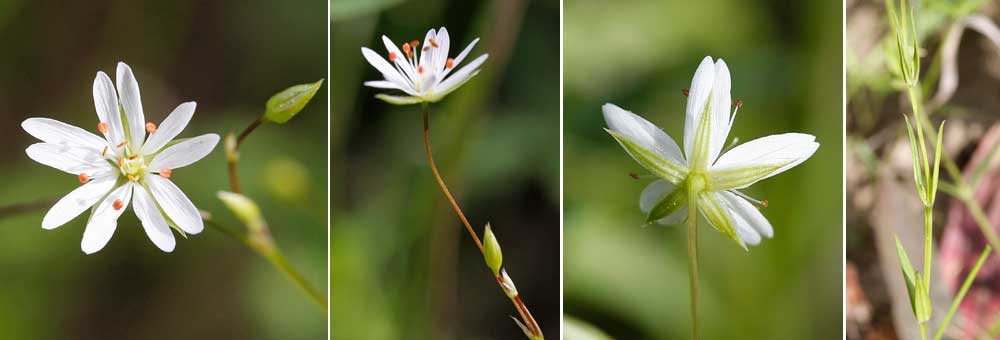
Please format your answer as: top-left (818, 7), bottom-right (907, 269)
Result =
top-left (145, 174), bottom-right (205, 234)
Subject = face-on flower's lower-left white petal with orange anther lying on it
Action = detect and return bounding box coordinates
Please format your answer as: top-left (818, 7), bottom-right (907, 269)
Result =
top-left (80, 182), bottom-right (133, 254)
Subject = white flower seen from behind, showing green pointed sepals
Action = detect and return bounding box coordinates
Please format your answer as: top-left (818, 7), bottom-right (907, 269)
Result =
top-left (603, 57), bottom-right (819, 249)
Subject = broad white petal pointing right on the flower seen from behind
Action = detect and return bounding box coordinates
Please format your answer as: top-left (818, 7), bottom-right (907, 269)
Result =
top-left (709, 133), bottom-right (819, 190)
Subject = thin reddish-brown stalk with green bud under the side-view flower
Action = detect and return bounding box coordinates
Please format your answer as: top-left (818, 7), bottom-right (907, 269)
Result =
top-left (421, 102), bottom-right (545, 340)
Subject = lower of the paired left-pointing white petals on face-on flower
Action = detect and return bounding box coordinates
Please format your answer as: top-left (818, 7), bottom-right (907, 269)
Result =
top-left (24, 143), bottom-right (115, 177)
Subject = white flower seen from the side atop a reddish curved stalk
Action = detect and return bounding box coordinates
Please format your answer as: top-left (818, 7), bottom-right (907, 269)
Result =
top-left (361, 27), bottom-right (489, 105)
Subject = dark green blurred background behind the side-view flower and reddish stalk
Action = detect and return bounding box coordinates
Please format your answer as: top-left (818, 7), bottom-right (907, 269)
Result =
top-left (330, 0), bottom-right (559, 339)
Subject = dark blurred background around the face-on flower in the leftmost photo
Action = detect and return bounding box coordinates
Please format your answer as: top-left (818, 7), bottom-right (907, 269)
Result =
top-left (0, 0), bottom-right (328, 339)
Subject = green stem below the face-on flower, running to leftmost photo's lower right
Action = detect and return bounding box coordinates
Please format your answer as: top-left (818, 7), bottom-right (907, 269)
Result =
top-left (205, 219), bottom-right (327, 312)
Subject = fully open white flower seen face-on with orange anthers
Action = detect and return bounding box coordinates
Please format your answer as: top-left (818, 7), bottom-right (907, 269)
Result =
top-left (21, 63), bottom-right (219, 254)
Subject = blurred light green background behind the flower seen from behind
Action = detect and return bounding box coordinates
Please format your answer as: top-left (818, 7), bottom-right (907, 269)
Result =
top-left (564, 0), bottom-right (843, 339)
